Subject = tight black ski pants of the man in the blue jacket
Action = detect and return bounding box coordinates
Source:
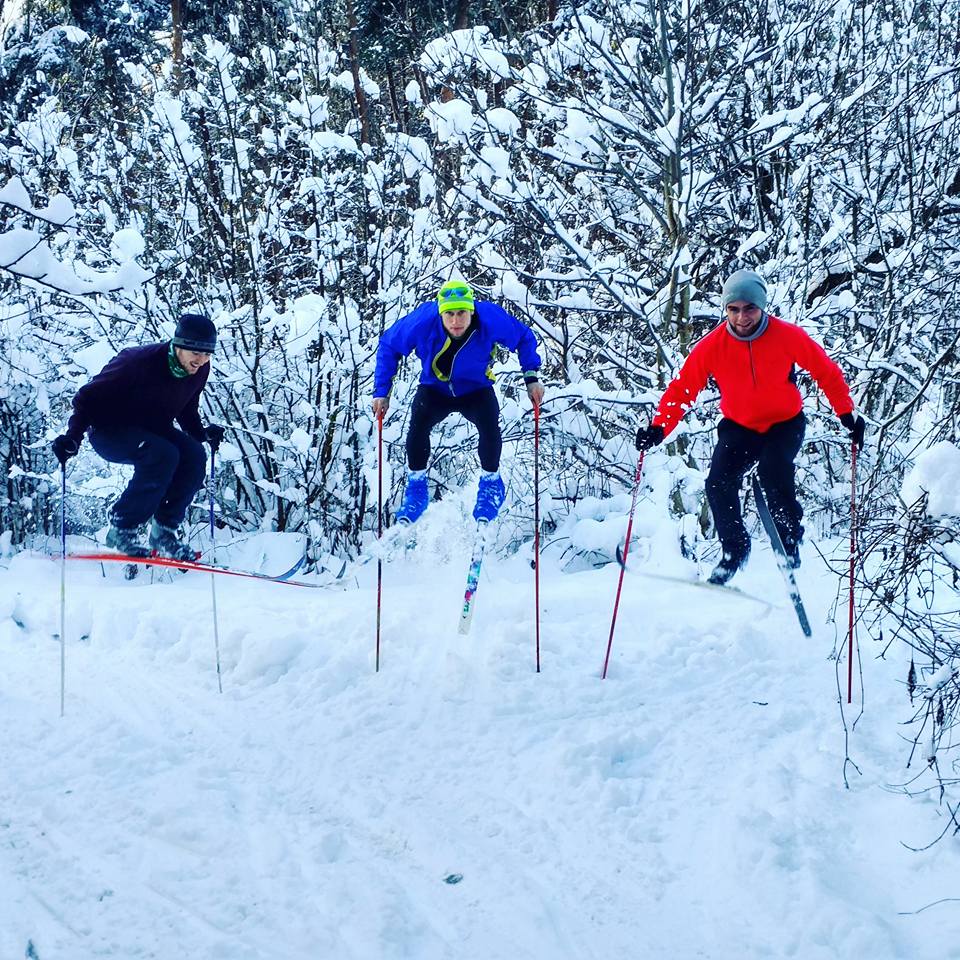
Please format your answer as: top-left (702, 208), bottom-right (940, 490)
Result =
top-left (407, 384), bottom-right (503, 473)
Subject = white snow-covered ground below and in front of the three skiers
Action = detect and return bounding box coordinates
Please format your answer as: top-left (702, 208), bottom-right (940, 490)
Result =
top-left (0, 506), bottom-right (960, 960)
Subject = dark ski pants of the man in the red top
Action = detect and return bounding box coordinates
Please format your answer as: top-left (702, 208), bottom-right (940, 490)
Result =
top-left (706, 413), bottom-right (807, 559)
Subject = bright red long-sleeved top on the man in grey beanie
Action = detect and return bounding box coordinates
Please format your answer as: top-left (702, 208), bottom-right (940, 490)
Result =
top-left (653, 316), bottom-right (853, 435)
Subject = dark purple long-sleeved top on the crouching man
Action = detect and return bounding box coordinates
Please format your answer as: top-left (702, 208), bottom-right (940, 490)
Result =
top-left (67, 343), bottom-right (210, 446)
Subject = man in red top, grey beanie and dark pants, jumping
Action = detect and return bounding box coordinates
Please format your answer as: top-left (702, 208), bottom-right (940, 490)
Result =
top-left (637, 270), bottom-right (864, 584)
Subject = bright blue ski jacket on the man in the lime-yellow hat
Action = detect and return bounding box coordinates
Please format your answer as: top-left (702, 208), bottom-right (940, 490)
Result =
top-left (373, 300), bottom-right (541, 397)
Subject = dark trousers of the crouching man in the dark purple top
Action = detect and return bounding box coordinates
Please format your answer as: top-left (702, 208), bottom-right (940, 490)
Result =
top-left (90, 427), bottom-right (207, 528)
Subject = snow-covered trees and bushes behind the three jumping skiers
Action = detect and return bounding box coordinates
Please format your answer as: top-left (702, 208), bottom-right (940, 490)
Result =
top-left (0, 0), bottom-right (960, 829)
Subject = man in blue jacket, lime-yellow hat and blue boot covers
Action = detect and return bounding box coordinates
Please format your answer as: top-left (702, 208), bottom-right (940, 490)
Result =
top-left (373, 280), bottom-right (543, 523)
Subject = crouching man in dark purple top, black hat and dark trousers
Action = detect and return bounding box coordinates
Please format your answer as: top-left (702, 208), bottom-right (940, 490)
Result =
top-left (51, 313), bottom-right (224, 560)
